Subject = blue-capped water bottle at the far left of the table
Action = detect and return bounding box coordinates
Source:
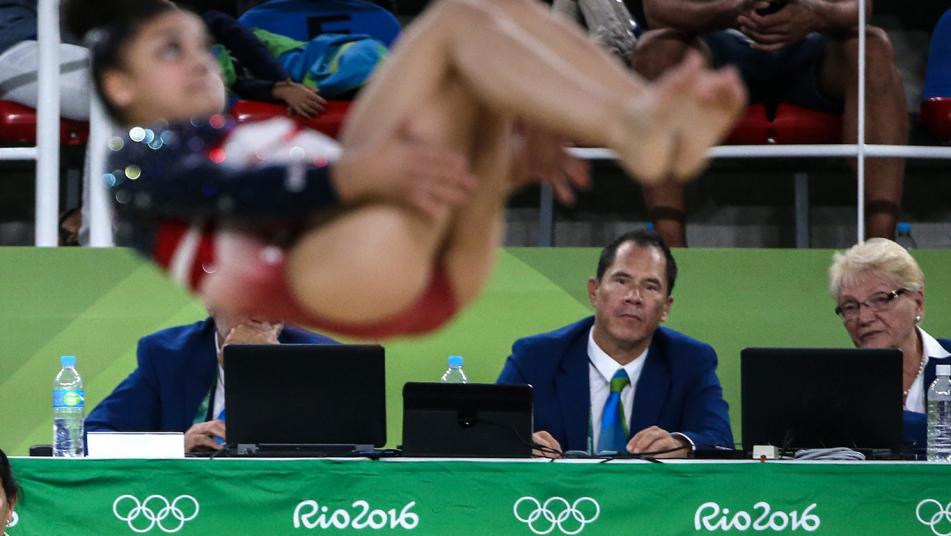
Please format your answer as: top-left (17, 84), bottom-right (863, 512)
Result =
top-left (53, 355), bottom-right (86, 457)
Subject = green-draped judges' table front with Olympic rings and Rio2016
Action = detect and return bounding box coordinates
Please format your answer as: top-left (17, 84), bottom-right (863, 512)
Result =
top-left (9, 458), bottom-right (951, 536)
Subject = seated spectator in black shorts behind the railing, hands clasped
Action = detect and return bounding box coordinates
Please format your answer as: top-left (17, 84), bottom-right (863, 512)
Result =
top-left (632, 0), bottom-right (908, 246)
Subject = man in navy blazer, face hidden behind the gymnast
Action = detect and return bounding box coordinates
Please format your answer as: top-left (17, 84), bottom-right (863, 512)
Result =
top-left (86, 311), bottom-right (336, 452)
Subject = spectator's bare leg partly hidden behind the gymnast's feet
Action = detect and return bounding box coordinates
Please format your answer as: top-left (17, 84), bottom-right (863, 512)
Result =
top-left (631, 30), bottom-right (710, 247)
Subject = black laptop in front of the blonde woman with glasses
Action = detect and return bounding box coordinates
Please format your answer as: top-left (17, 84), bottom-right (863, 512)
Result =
top-left (740, 348), bottom-right (902, 452)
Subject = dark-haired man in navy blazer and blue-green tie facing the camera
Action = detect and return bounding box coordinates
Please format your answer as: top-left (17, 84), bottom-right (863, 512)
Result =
top-left (498, 231), bottom-right (733, 457)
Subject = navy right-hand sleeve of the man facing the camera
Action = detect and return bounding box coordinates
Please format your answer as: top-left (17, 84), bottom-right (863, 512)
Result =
top-left (672, 346), bottom-right (734, 449)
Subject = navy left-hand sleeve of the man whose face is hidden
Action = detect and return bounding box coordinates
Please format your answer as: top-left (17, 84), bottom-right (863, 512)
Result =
top-left (86, 337), bottom-right (161, 432)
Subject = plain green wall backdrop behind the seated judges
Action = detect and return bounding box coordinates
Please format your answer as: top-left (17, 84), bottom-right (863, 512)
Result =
top-left (0, 248), bottom-right (951, 455)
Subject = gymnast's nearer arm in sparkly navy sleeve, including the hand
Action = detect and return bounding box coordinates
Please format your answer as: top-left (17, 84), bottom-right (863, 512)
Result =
top-left (106, 118), bottom-right (478, 220)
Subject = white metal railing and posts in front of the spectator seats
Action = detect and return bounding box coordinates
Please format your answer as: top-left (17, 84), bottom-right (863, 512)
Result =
top-left (0, 0), bottom-right (951, 246)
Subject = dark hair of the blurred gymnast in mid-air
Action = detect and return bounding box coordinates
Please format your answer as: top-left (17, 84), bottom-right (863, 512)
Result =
top-left (62, 0), bottom-right (178, 121)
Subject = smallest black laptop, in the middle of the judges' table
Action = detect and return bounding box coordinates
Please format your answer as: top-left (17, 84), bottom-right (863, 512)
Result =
top-left (403, 382), bottom-right (533, 458)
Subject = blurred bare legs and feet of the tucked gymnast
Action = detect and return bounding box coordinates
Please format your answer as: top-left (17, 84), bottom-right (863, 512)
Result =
top-left (288, 0), bottom-right (744, 322)
